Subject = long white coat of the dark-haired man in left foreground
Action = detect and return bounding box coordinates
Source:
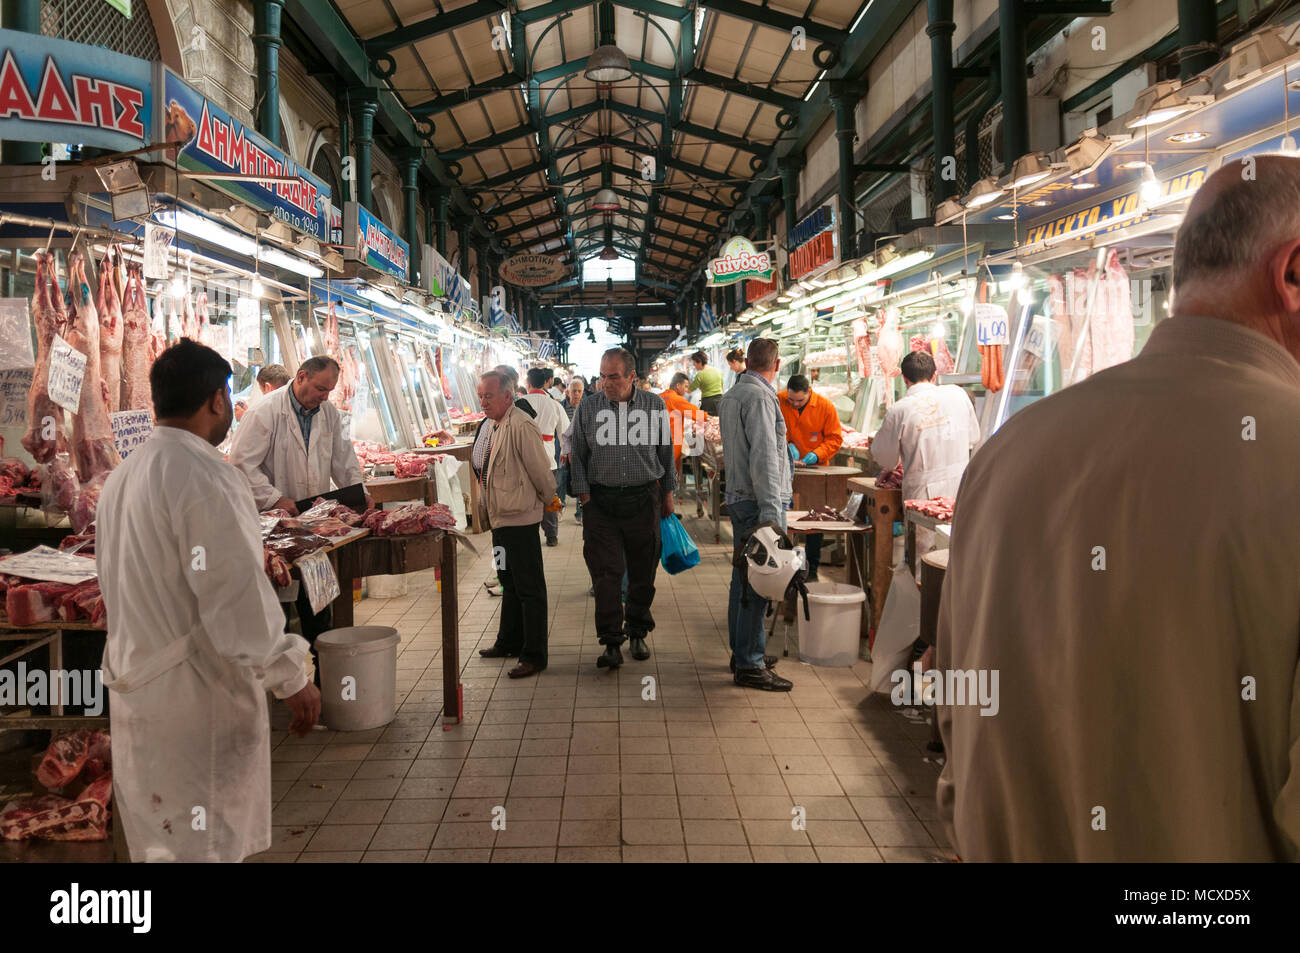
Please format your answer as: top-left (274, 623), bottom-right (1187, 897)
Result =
top-left (95, 426), bottom-right (308, 862)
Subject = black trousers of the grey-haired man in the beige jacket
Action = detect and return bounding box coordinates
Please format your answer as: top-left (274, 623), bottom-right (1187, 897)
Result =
top-left (491, 523), bottom-right (547, 668)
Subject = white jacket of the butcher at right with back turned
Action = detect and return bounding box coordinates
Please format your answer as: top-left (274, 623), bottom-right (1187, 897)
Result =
top-left (873, 382), bottom-right (979, 499)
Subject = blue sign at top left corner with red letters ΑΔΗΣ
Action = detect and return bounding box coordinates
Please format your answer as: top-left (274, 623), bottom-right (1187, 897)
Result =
top-left (0, 30), bottom-right (155, 152)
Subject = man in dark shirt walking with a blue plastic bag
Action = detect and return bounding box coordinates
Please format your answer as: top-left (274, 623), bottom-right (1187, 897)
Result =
top-left (569, 347), bottom-right (676, 668)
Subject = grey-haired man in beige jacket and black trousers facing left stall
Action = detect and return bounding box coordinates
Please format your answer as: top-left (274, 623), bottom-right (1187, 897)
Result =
top-left (471, 371), bottom-right (559, 679)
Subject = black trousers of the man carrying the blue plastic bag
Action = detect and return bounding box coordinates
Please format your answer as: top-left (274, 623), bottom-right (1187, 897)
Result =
top-left (582, 484), bottom-right (662, 645)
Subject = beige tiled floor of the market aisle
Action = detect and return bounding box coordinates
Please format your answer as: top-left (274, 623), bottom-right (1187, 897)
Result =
top-left (257, 507), bottom-right (948, 862)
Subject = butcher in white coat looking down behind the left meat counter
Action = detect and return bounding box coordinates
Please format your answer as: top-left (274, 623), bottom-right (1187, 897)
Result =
top-left (230, 356), bottom-right (371, 644)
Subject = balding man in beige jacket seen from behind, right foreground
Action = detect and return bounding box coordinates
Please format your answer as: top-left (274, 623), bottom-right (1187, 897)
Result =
top-left (937, 156), bottom-right (1300, 861)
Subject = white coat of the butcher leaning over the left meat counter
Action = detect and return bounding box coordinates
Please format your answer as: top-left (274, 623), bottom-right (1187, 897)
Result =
top-left (230, 384), bottom-right (364, 510)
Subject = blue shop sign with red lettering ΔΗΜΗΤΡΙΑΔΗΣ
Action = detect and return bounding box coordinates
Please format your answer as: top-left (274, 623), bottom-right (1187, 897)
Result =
top-left (157, 70), bottom-right (330, 242)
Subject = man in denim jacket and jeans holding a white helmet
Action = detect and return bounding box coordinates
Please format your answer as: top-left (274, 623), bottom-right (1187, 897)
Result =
top-left (718, 338), bottom-right (793, 692)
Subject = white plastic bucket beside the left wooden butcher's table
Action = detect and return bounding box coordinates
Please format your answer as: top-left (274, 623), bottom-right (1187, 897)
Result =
top-left (316, 625), bottom-right (402, 731)
